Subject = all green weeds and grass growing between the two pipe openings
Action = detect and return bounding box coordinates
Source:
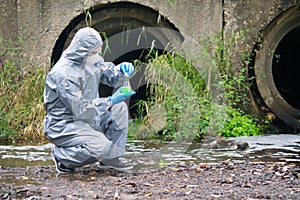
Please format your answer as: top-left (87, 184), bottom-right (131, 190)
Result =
top-left (130, 31), bottom-right (263, 142)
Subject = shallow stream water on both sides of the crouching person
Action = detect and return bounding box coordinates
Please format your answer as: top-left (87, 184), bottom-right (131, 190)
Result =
top-left (0, 134), bottom-right (300, 169)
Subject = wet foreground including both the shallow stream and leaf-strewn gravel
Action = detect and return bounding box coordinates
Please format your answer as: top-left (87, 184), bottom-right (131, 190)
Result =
top-left (0, 135), bottom-right (300, 199)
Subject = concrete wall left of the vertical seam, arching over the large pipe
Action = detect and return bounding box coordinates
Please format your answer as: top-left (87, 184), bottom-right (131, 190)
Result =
top-left (0, 0), bottom-right (222, 65)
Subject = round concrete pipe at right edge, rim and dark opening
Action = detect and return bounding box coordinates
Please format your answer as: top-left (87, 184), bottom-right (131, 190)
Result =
top-left (254, 7), bottom-right (300, 131)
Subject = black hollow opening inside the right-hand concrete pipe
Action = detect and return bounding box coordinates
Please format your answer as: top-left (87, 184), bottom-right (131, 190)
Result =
top-left (272, 26), bottom-right (300, 109)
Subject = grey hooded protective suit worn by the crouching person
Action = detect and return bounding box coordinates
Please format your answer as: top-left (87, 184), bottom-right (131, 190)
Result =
top-left (44, 28), bottom-right (128, 168)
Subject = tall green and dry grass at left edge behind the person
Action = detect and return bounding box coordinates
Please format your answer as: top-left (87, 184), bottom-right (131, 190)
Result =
top-left (0, 36), bottom-right (46, 144)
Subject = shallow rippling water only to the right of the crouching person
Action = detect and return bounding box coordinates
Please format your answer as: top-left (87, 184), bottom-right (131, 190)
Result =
top-left (127, 134), bottom-right (300, 168)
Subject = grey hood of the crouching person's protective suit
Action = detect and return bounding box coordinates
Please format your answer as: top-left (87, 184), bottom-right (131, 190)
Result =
top-left (63, 27), bottom-right (103, 67)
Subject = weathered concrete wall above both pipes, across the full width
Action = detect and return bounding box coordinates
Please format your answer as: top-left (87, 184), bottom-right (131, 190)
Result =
top-left (0, 0), bottom-right (297, 66)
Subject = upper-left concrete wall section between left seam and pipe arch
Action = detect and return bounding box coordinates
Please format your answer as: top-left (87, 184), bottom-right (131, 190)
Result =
top-left (17, 0), bottom-right (82, 66)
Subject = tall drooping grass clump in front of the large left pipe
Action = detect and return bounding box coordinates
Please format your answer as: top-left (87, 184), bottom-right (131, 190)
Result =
top-left (131, 54), bottom-right (210, 141)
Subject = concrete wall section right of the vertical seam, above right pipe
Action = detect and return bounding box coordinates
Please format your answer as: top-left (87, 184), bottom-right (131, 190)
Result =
top-left (223, 0), bottom-right (300, 60)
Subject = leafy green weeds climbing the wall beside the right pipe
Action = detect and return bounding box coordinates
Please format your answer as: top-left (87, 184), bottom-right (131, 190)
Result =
top-left (210, 31), bottom-right (263, 137)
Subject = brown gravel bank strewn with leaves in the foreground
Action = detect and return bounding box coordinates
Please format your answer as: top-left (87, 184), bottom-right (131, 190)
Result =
top-left (0, 160), bottom-right (300, 200)
